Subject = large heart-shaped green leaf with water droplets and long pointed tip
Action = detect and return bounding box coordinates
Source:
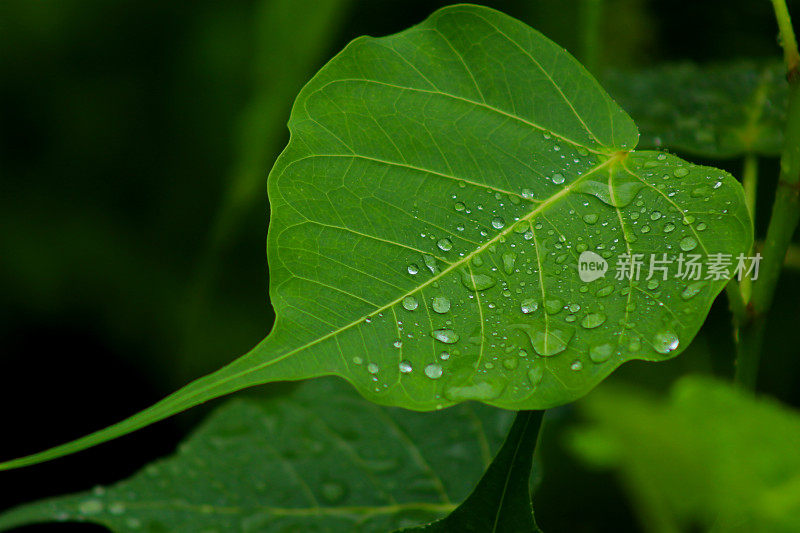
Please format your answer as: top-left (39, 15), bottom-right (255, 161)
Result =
top-left (0, 5), bottom-right (752, 468)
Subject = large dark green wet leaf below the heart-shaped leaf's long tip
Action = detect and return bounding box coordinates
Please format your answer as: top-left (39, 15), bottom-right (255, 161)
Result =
top-left (0, 379), bottom-right (512, 533)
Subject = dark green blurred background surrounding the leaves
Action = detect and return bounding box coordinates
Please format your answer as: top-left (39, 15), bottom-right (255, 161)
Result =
top-left (0, 0), bottom-right (800, 532)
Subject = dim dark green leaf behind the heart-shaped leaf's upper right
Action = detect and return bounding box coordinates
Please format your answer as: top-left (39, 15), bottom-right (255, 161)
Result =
top-left (603, 62), bottom-right (788, 158)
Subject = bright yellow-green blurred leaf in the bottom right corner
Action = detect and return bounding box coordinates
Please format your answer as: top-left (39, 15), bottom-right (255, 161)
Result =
top-left (571, 377), bottom-right (800, 533)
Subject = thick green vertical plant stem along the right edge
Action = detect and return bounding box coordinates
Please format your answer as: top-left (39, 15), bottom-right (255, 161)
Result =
top-left (735, 0), bottom-right (800, 390)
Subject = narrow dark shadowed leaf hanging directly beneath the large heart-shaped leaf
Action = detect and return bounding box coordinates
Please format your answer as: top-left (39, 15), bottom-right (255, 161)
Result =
top-left (403, 411), bottom-right (544, 533)
